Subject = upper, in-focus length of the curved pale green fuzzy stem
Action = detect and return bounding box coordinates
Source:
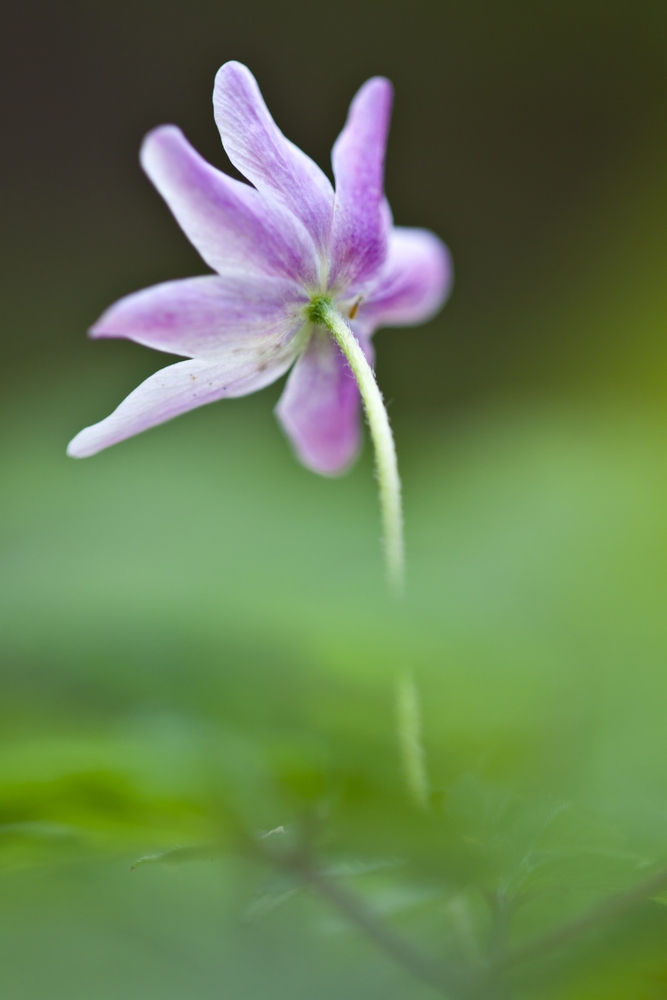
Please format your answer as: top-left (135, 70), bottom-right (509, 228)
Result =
top-left (312, 298), bottom-right (405, 595)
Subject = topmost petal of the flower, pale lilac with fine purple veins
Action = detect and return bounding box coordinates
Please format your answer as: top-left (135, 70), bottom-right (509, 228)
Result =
top-left (213, 62), bottom-right (334, 250)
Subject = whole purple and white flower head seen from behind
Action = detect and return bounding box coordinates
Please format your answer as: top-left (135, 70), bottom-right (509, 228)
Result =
top-left (68, 62), bottom-right (451, 475)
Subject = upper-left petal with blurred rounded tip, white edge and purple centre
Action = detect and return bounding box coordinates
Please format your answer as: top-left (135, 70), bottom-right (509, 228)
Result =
top-left (141, 125), bottom-right (317, 282)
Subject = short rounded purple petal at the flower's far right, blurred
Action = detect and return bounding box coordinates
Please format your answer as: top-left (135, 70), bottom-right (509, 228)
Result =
top-left (359, 226), bottom-right (453, 329)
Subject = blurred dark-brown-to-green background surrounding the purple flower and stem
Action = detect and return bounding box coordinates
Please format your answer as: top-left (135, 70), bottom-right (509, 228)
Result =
top-left (0, 0), bottom-right (667, 1000)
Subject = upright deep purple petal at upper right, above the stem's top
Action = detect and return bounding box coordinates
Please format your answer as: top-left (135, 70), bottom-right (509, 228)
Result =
top-left (331, 77), bottom-right (393, 286)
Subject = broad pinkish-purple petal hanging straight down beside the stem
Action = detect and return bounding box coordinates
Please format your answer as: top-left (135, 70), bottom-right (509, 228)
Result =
top-left (276, 328), bottom-right (372, 476)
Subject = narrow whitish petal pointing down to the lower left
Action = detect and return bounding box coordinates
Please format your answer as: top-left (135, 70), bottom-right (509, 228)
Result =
top-left (67, 344), bottom-right (302, 458)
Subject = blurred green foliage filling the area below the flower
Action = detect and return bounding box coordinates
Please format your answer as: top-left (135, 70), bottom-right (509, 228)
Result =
top-left (0, 380), bottom-right (667, 1000)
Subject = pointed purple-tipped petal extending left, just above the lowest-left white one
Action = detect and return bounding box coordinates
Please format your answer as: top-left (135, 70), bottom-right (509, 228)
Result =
top-left (90, 272), bottom-right (307, 362)
